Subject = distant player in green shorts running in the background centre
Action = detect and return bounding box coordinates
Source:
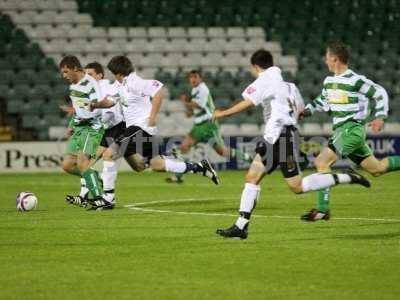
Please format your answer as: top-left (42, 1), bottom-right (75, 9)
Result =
top-left (167, 70), bottom-right (251, 183)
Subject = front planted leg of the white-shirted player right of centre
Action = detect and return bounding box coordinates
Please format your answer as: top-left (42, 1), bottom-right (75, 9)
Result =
top-left (216, 154), bottom-right (266, 239)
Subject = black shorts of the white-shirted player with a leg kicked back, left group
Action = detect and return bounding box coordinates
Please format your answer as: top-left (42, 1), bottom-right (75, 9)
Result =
top-left (114, 126), bottom-right (158, 159)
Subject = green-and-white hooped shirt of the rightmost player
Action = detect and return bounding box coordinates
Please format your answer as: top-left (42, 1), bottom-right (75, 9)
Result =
top-left (306, 69), bottom-right (389, 129)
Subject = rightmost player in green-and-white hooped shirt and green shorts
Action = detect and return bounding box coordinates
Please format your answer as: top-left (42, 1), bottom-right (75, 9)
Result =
top-left (301, 42), bottom-right (400, 221)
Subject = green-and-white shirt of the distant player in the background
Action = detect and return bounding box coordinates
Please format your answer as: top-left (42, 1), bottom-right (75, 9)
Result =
top-left (191, 82), bottom-right (215, 124)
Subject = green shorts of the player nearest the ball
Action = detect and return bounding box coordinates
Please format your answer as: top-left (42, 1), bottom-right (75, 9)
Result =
top-left (65, 126), bottom-right (104, 158)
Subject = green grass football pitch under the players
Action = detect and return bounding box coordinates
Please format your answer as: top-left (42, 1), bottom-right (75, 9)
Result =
top-left (0, 172), bottom-right (400, 299)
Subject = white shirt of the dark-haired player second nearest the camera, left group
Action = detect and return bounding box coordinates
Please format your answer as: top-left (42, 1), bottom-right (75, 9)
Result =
top-left (118, 72), bottom-right (163, 135)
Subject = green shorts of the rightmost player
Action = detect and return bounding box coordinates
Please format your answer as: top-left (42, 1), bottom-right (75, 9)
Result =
top-left (328, 122), bottom-right (373, 165)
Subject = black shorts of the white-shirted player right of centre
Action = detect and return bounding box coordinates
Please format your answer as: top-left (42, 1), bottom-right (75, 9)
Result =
top-left (256, 126), bottom-right (308, 178)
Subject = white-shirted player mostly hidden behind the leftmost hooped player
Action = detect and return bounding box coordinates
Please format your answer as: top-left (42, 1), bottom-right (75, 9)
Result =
top-left (61, 62), bottom-right (126, 207)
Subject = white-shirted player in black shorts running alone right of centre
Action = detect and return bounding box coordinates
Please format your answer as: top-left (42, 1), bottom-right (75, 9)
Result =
top-left (213, 49), bottom-right (370, 239)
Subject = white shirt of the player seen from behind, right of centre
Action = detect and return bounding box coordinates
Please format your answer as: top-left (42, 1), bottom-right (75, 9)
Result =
top-left (242, 67), bottom-right (304, 144)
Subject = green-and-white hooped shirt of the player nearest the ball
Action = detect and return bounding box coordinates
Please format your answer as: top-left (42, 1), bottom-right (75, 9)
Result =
top-left (69, 74), bottom-right (102, 129)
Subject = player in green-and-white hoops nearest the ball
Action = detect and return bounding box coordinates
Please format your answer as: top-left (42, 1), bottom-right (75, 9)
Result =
top-left (59, 56), bottom-right (104, 205)
